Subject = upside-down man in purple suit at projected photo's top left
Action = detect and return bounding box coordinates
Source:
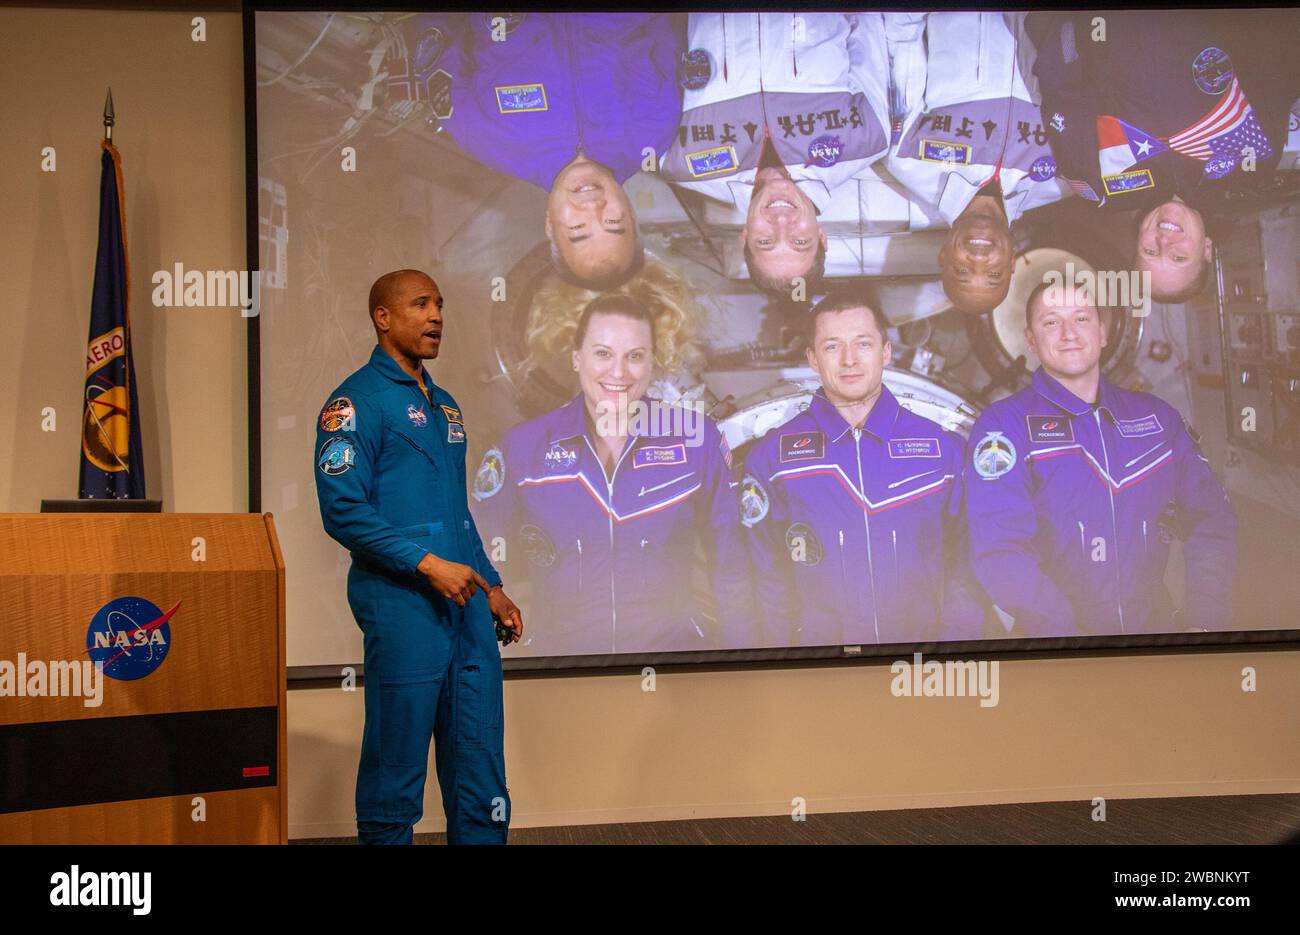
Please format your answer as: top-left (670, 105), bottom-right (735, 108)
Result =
top-left (404, 13), bottom-right (685, 290)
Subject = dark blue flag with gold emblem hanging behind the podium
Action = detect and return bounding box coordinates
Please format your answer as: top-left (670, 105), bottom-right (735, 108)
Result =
top-left (81, 140), bottom-right (144, 499)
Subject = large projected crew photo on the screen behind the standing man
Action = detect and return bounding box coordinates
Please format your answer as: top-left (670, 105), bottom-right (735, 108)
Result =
top-left (256, 3), bottom-right (1300, 670)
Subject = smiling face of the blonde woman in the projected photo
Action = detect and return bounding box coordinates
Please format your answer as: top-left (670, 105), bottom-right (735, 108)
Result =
top-left (573, 312), bottom-right (654, 420)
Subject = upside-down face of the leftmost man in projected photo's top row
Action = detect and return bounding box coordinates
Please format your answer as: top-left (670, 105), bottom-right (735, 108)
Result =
top-left (546, 153), bottom-right (637, 283)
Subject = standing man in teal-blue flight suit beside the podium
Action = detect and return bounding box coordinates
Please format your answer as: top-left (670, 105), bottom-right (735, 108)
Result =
top-left (315, 269), bottom-right (524, 844)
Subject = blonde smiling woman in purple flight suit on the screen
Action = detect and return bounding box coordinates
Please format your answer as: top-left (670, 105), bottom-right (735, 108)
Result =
top-left (473, 294), bottom-right (750, 655)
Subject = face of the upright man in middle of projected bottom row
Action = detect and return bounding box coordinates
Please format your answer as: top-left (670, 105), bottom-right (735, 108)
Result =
top-left (807, 308), bottom-right (893, 406)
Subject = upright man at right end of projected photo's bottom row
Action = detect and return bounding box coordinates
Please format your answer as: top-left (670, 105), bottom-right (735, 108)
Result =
top-left (966, 282), bottom-right (1236, 637)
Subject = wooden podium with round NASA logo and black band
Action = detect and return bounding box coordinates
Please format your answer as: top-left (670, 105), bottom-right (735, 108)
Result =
top-left (0, 514), bottom-right (289, 844)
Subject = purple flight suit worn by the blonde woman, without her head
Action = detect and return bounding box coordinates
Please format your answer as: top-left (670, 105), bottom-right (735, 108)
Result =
top-left (473, 394), bottom-right (753, 655)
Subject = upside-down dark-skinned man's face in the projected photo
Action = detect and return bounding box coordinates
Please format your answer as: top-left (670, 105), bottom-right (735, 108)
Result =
top-left (939, 198), bottom-right (1015, 315)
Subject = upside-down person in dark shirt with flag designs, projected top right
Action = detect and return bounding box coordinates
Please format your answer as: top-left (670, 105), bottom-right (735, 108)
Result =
top-left (1027, 9), bottom-right (1300, 302)
